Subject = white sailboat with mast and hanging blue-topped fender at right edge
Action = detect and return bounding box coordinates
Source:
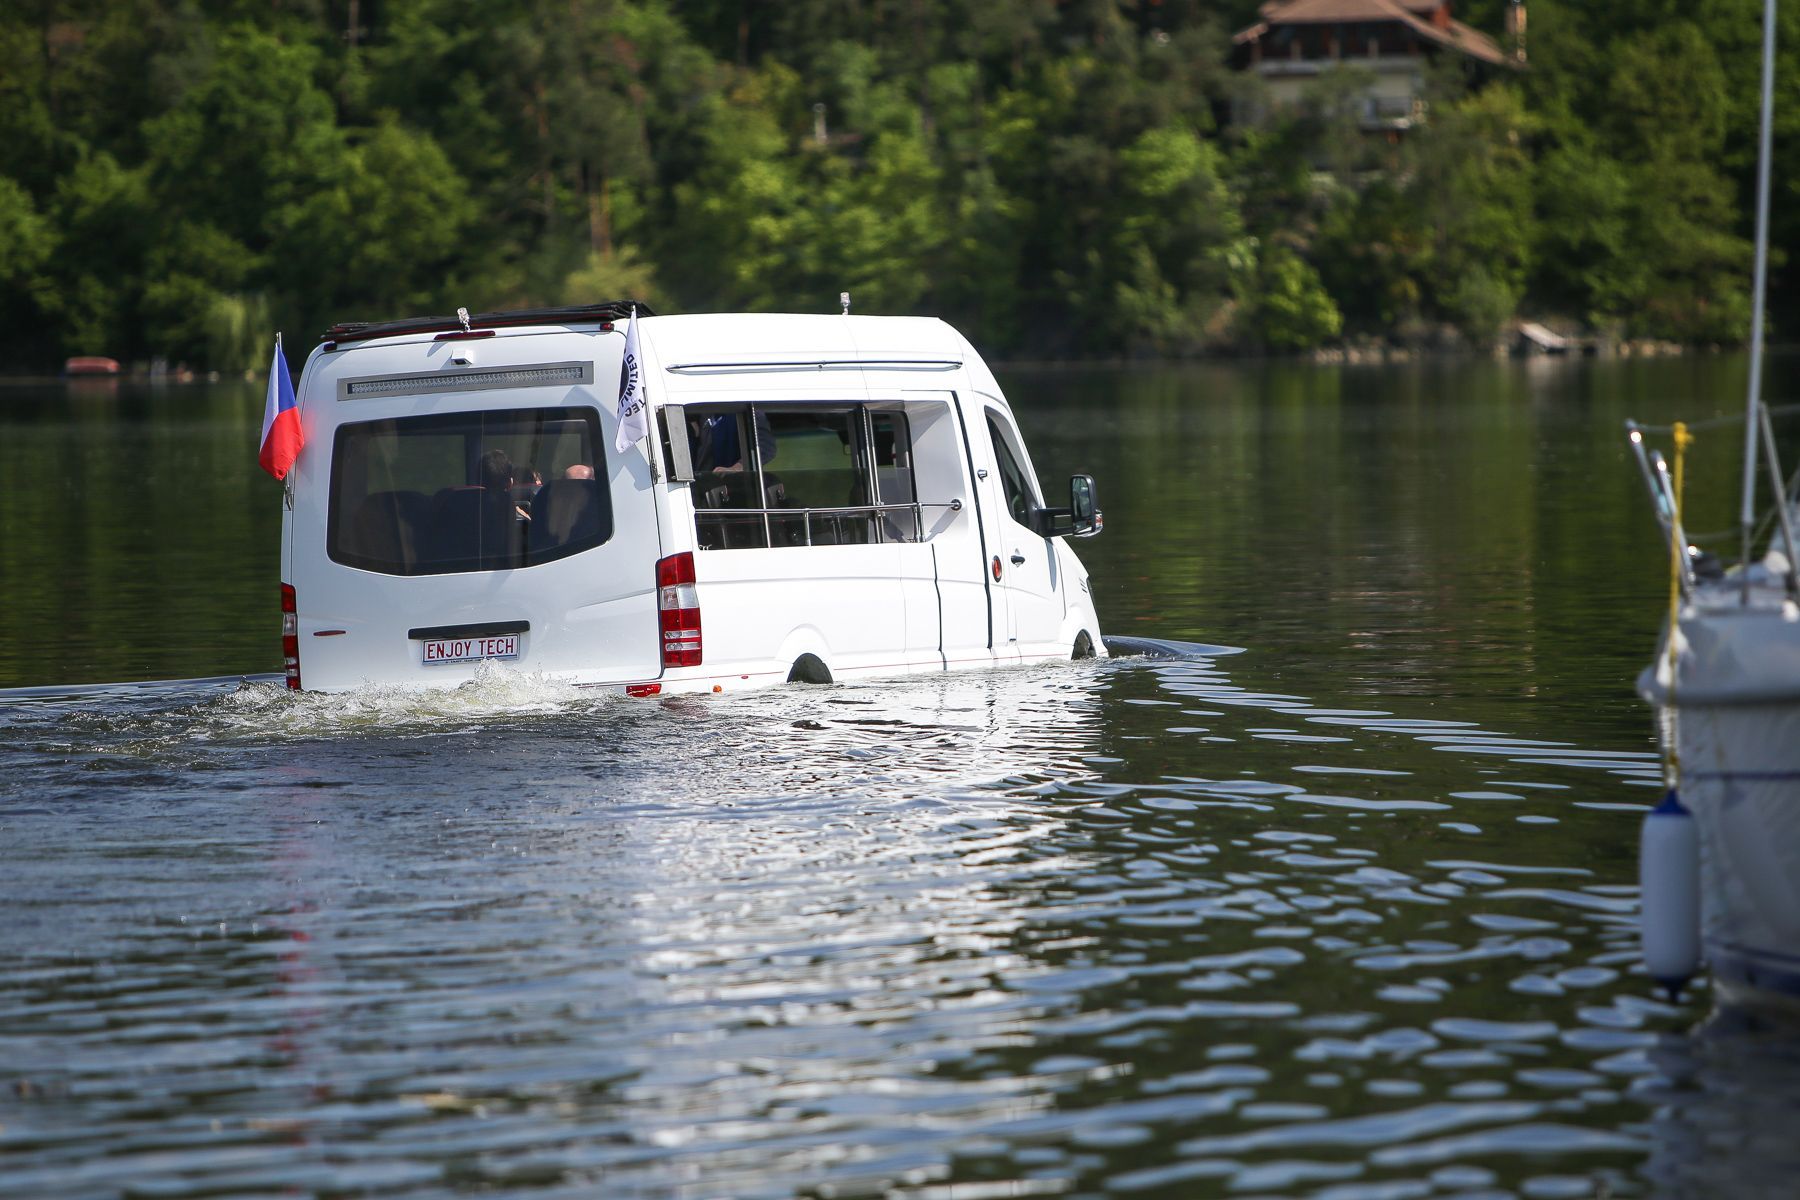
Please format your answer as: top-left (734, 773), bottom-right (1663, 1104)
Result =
top-left (1627, 0), bottom-right (1800, 1011)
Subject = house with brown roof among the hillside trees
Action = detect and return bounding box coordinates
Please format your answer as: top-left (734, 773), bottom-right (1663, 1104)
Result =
top-left (1231, 0), bottom-right (1525, 137)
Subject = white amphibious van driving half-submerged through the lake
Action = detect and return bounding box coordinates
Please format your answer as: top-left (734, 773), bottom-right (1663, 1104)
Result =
top-left (281, 304), bottom-right (1105, 696)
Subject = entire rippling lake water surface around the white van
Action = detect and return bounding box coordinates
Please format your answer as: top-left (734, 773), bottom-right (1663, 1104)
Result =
top-left (0, 356), bottom-right (1800, 1200)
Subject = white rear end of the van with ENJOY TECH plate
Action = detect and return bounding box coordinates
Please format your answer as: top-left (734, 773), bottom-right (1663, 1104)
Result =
top-left (293, 341), bottom-right (661, 689)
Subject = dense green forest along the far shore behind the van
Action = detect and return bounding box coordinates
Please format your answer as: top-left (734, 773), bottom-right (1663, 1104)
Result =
top-left (0, 0), bottom-right (1800, 371)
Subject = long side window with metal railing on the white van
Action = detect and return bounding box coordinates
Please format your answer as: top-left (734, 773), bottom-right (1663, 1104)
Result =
top-left (686, 403), bottom-right (920, 551)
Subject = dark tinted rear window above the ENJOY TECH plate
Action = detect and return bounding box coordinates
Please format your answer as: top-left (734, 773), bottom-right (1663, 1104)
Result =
top-left (326, 408), bottom-right (612, 576)
